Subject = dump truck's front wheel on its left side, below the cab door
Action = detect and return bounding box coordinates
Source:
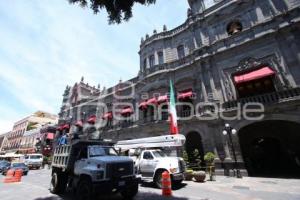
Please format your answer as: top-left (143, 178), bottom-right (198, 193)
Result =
top-left (76, 178), bottom-right (94, 200)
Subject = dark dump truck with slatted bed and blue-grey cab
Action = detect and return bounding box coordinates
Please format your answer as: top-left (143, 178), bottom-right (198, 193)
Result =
top-left (50, 141), bottom-right (139, 200)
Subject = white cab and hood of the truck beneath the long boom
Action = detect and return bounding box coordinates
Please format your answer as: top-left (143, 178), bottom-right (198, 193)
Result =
top-left (135, 149), bottom-right (185, 188)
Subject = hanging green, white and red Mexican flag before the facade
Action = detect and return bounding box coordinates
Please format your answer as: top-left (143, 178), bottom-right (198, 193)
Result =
top-left (169, 80), bottom-right (178, 135)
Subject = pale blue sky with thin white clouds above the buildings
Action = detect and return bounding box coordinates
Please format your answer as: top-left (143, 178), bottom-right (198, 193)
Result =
top-left (0, 0), bottom-right (188, 134)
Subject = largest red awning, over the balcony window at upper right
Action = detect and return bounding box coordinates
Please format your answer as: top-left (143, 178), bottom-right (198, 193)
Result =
top-left (234, 67), bottom-right (275, 84)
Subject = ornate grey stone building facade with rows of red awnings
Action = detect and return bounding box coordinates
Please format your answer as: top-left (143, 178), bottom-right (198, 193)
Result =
top-left (60, 0), bottom-right (300, 177)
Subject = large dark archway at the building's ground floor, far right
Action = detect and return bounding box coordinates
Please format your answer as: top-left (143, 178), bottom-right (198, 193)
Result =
top-left (238, 120), bottom-right (300, 178)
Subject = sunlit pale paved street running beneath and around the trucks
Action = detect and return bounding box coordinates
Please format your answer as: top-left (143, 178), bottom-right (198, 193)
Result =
top-left (0, 169), bottom-right (300, 200)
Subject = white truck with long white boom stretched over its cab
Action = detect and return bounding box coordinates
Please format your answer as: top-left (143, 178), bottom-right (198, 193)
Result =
top-left (115, 134), bottom-right (185, 188)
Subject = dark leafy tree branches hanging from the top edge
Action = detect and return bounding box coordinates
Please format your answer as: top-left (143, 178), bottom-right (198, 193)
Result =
top-left (68, 0), bottom-right (156, 24)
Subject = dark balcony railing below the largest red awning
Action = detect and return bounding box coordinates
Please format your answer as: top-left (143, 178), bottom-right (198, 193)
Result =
top-left (223, 88), bottom-right (300, 110)
